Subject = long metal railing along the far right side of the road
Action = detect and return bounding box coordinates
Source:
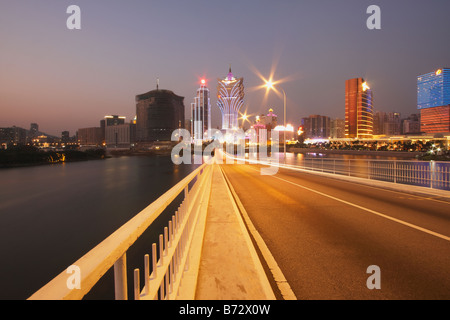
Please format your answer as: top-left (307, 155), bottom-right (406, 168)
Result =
top-left (286, 158), bottom-right (450, 190)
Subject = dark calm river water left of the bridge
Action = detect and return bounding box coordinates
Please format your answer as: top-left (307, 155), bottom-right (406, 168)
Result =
top-left (0, 156), bottom-right (197, 300)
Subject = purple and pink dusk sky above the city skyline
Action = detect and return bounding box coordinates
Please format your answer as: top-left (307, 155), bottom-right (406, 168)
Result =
top-left (0, 0), bottom-right (450, 136)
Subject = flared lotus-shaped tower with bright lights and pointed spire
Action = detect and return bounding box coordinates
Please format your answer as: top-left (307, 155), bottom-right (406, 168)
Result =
top-left (217, 67), bottom-right (244, 130)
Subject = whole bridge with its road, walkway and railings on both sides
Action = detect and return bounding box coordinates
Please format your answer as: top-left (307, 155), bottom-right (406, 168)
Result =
top-left (29, 152), bottom-right (450, 300)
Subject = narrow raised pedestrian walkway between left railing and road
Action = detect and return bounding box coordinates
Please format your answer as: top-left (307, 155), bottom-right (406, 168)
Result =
top-left (195, 164), bottom-right (275, 300)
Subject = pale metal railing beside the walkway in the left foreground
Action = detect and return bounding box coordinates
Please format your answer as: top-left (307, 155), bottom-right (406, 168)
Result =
top-left (29, 163), bottom-right (212, 300)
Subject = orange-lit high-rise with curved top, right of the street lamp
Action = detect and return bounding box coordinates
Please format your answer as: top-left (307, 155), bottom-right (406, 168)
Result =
top-left (345, 78), bottom-right (373, 139)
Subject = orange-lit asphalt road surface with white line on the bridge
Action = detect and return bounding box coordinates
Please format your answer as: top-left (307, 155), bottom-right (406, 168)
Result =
top-left (221, 164), bottom-right (450, 300)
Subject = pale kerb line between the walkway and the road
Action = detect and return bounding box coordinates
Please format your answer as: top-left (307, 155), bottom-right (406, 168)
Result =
top-left (219, 166), bottom-right (297, 300)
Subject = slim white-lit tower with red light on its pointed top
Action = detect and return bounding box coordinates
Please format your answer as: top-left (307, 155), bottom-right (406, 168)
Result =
top-left (191, 79), bottom-right (211, 142)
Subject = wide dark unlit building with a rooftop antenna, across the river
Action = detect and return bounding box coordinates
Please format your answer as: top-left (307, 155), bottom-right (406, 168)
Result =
top-left (136, 86), bottom-right (184, 142)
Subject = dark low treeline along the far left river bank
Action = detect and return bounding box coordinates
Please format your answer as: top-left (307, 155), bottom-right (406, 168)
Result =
top-left (0, 146), bottom-right (106, 168)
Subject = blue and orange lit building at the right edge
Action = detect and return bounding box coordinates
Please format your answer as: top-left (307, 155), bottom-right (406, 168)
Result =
top-left (417, 68), bottom-right (450, 134)
